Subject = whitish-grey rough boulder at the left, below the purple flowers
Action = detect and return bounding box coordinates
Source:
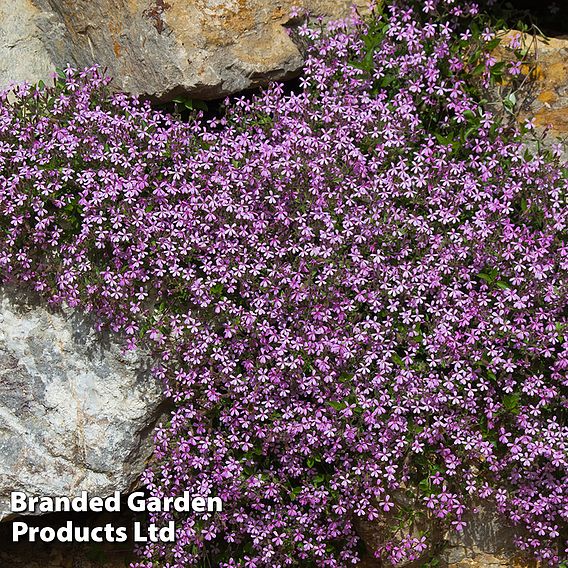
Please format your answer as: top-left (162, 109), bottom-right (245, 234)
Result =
top-left (0, 290), bottom-right (162, 519)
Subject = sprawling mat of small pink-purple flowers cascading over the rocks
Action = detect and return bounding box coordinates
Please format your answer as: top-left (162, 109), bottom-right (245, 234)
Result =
top-left (0, 0), bottom-right (568, 568)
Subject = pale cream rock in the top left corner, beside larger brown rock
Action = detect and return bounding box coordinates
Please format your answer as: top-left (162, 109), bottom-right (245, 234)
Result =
top-left (0, 0), bottom-right (55, 88)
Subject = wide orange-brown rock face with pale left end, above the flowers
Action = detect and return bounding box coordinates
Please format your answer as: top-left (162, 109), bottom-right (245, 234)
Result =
top-left (0, 0), bottom-right (367, 100)
